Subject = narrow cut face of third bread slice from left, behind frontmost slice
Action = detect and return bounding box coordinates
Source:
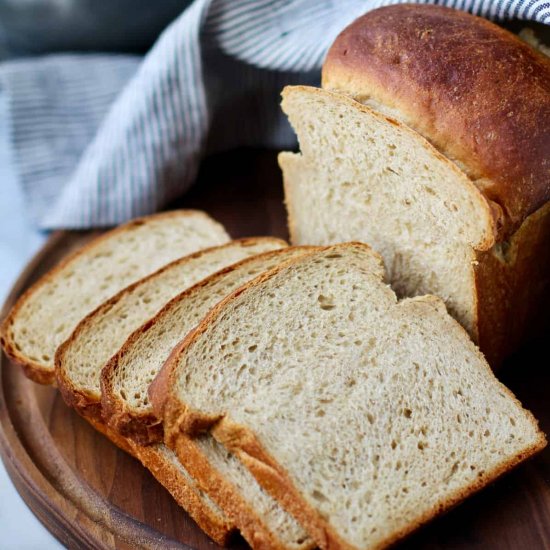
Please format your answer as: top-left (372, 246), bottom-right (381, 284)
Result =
top-left (102, 247), bottom-right (310, 444)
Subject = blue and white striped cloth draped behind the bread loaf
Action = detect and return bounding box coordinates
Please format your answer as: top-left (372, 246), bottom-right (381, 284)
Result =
top-left (0, 0), bottom-right (550, 228)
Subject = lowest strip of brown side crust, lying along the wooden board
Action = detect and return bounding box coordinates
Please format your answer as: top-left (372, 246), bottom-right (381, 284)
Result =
top-left (86, 418), bottom-right (236, 546)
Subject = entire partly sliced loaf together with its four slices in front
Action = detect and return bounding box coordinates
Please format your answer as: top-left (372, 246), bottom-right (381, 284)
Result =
top-left (0, 5), bottom-right (550, 550)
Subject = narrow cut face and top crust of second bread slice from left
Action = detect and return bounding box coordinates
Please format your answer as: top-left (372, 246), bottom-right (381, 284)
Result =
top-left (55, 237), bottom-right (286, 418)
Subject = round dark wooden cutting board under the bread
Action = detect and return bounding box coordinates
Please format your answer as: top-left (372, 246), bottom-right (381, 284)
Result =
top-left (0, 151), bottom-right (550, 550)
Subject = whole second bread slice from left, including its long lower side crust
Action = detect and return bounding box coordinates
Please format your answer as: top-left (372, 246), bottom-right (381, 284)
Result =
top-left (56, 237), bottom-right (286, 543)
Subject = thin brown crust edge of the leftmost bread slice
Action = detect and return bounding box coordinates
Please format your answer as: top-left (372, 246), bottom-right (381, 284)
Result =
top-left (0, 210), bottom-right (226, 384)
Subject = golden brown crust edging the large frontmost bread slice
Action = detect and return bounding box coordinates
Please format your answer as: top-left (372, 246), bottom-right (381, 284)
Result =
top-left (158, 243), bottom-right (546, 550)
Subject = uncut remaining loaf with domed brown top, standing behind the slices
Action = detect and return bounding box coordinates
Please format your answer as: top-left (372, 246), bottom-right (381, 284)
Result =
top-left (280, 5), bottom-right (550, 366)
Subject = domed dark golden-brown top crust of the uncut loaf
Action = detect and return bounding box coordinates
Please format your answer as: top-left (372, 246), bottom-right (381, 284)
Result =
top-left (323, 5), bottom-right (550, 234)
